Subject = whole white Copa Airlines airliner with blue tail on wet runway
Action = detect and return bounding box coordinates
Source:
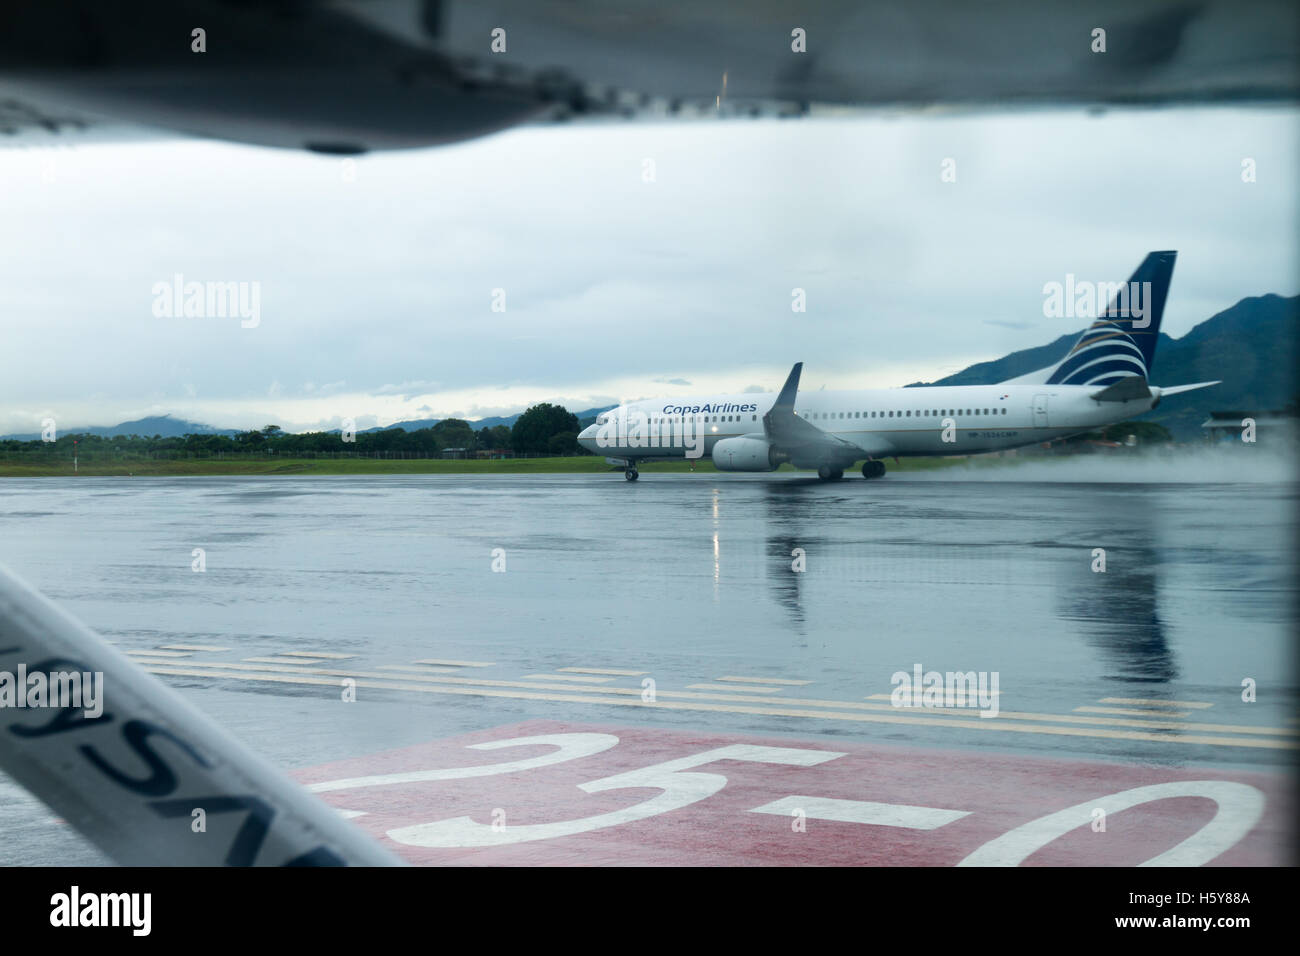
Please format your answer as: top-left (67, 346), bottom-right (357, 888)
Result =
top-left (579, 252), bottom-right (1218, 481)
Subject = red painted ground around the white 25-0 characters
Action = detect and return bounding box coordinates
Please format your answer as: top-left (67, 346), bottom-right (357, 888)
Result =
top-left (295, 721), bottom-right (1292, 866)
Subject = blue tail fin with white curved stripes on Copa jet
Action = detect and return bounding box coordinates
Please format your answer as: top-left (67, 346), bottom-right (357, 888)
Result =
top-left (1047, 252), bottom-right (1178, 385)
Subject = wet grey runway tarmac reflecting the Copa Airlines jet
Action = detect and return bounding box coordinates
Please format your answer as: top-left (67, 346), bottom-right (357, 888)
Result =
top-left (0, 472), bottom-right (1297, 864)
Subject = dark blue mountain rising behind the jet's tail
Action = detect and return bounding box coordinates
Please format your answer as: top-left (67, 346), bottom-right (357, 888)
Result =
top-left (907, 295), bottom-right (1300, 441)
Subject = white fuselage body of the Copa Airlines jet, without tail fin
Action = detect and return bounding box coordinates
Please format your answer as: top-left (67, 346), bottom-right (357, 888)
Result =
top-left (579, 384), bottom-right (1160, 460)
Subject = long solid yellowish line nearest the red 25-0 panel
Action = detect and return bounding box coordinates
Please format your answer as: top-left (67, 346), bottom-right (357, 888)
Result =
top-left (137, 663), bottom-right (1295, 750)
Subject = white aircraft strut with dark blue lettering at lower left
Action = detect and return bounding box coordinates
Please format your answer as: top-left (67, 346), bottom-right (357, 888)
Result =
top-left (0, 568), bottom-right (400, 866)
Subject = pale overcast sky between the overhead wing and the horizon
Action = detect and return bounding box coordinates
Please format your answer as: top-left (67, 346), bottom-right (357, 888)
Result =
top-left (0, 108), bottom-right (1300, 433)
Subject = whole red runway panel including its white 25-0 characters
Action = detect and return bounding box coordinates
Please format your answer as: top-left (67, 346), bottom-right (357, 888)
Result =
top-left (293, 723), bottom-right (1292, 866)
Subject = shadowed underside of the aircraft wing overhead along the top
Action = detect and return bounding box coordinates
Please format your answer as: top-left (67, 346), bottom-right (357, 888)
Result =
top-left (0, 0), bottom-right (1300, 155)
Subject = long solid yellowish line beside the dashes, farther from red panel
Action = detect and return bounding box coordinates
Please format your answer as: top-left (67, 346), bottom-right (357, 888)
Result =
top-left (134, 661), bottom-right (1300, 739)
